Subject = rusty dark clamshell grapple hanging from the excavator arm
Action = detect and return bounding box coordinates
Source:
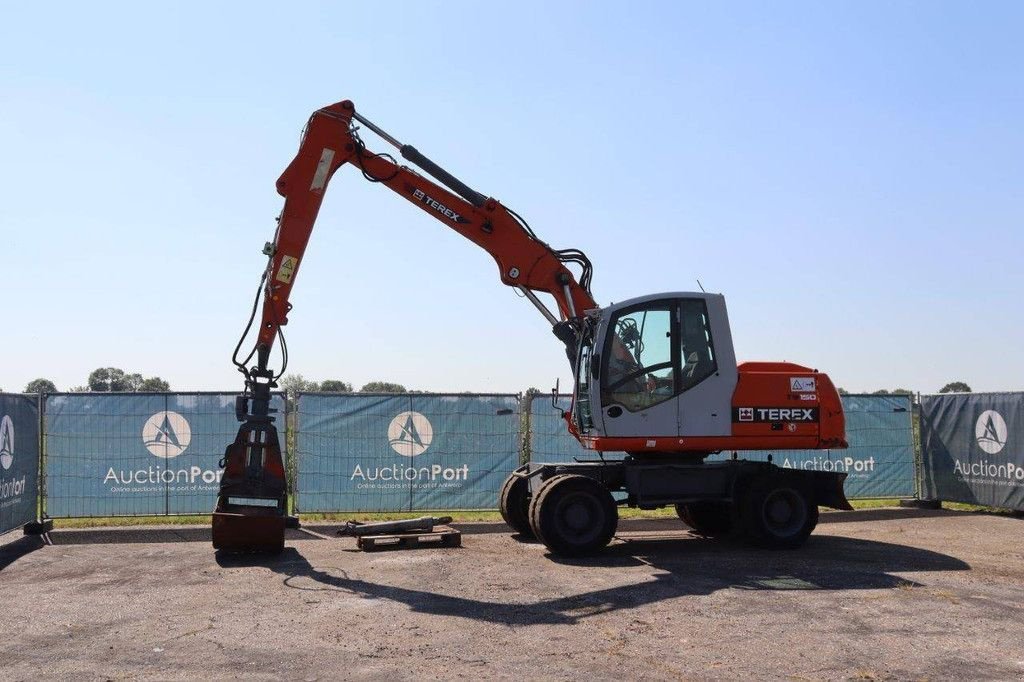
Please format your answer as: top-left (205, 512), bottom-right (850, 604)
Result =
top-left (213, 416), bottom-right (288, 553)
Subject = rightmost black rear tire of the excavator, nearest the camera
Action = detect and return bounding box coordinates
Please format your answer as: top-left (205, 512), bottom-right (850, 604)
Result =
top-left (738, 474), bottom-right (818, 549)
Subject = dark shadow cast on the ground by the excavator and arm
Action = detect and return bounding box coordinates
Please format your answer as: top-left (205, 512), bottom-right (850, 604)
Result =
top-left (217, 536), bottom-right (970, 625)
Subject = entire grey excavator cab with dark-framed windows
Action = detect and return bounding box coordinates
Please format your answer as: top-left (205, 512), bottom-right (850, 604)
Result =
top-left (573, 293), bottom-right (736, 440)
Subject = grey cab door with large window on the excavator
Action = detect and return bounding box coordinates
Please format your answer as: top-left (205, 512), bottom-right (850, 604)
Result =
top-left (591, 299), bottom-right (681, 437)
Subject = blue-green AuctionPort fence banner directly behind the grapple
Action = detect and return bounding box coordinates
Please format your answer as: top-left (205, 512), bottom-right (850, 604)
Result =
top-left (43, 393), bottom-right (285, 517)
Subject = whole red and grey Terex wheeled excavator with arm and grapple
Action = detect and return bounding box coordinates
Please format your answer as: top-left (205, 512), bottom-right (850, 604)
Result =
top-left (213, 100), bottom-right (850, 555)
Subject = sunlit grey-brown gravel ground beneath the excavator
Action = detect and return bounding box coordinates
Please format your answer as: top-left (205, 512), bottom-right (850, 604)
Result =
top-left (0, 510), bottom-right (1024, 680)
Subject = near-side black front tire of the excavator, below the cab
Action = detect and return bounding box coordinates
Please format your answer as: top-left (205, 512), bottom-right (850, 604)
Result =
top-left (529, 474), bottom-right (618, 557)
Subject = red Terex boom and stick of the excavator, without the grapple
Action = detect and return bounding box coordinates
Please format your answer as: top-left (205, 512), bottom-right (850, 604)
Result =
top-left (258, 100), bottom-right (597, 356)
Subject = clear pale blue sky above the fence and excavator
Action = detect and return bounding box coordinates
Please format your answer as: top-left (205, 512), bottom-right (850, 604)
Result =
top-left (0, 2), bottom-right (1024, 392)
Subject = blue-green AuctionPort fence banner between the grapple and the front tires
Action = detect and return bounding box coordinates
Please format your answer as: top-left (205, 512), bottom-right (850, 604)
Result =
top-left (296, 393), bottom-right (519, 512)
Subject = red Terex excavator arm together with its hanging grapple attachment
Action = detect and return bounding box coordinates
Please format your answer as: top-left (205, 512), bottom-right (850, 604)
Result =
top-left (213, 100), bottom-right (598, 551)
